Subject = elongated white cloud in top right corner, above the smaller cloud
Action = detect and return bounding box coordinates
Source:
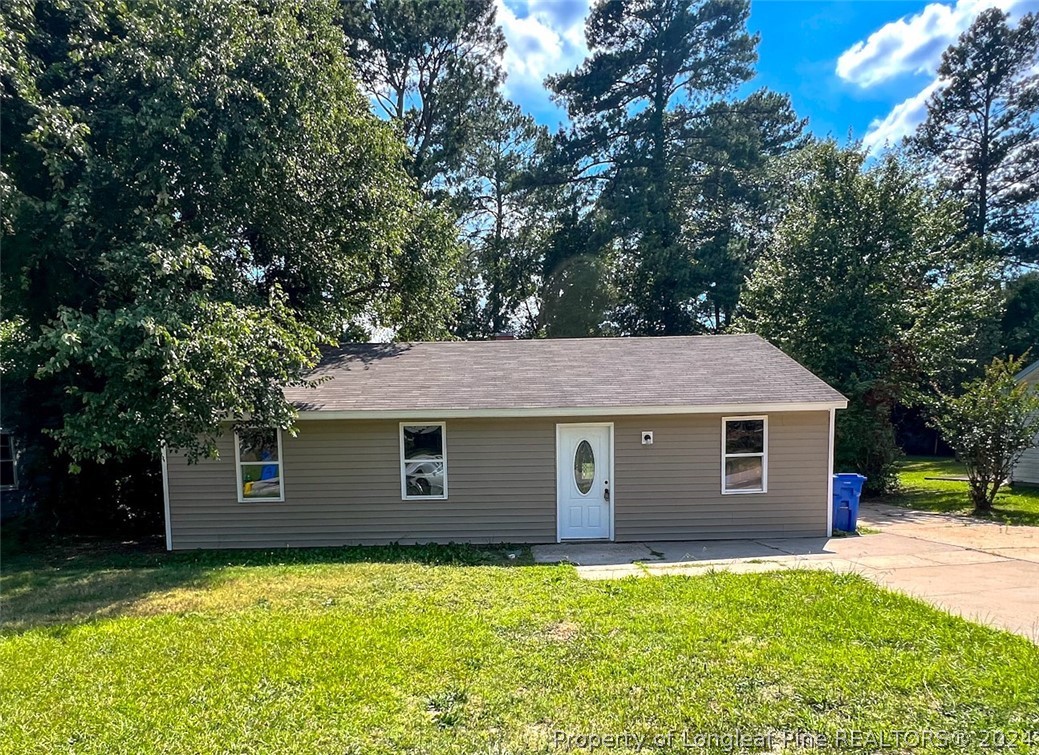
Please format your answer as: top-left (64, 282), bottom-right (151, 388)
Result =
top-left (836, 0), bottom-right (1039, 87)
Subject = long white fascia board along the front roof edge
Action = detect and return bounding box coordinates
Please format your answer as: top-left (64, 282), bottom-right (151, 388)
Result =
top-left (298, 401), bottom-right (848, 420)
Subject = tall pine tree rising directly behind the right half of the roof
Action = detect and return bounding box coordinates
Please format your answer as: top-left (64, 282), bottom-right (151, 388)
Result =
top-left (549, 0), bottom-right (756, 334)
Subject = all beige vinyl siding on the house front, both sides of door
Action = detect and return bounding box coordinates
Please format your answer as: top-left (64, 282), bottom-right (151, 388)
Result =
top-left (167, 411), bottom-right (829, 549)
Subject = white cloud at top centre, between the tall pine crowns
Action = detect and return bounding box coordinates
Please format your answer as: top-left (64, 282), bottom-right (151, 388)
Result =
top-left (497, 0), bottom-right (588, 97)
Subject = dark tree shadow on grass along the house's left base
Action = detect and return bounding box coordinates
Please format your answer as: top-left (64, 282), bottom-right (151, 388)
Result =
top-left (0, 540), bottom-right (533, 636)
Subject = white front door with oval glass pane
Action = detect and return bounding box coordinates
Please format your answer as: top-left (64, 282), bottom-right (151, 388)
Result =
top-left (556, 424), bottom-right (613, 540)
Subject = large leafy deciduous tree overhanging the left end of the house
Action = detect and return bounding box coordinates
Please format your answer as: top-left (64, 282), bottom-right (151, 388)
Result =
top-left (0, 0), bottom-right (454, 462)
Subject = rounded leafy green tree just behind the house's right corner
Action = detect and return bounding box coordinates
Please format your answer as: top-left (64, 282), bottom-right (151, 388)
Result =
top-left (739, 143), bottom-right (1000, 489)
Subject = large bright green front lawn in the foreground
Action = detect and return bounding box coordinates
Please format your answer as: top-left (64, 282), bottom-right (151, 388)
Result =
top-left (0, 547), bottom-right (1039, 755)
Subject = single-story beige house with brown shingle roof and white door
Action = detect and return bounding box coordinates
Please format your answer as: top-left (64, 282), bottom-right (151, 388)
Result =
top-left (163, 335), bottom-right (847, 549)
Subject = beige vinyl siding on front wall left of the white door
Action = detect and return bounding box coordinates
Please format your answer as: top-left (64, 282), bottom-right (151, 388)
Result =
top-left (167, 417), bottom-right (556, 549)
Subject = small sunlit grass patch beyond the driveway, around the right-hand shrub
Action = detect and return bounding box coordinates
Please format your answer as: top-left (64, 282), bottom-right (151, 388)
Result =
top-left (881, 456), bottom-right (1039, 525)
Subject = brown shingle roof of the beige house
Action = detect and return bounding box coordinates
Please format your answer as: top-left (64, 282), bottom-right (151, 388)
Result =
top-left (286, 335), bottom-right (845, 413)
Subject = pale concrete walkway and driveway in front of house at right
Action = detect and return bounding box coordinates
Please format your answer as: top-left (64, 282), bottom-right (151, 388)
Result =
top-left (533, 504), bottom-right (1039, 643)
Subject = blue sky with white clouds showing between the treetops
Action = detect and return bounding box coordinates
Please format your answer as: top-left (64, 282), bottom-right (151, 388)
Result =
top-left (497, 0), bottom-right (1039, 147)
